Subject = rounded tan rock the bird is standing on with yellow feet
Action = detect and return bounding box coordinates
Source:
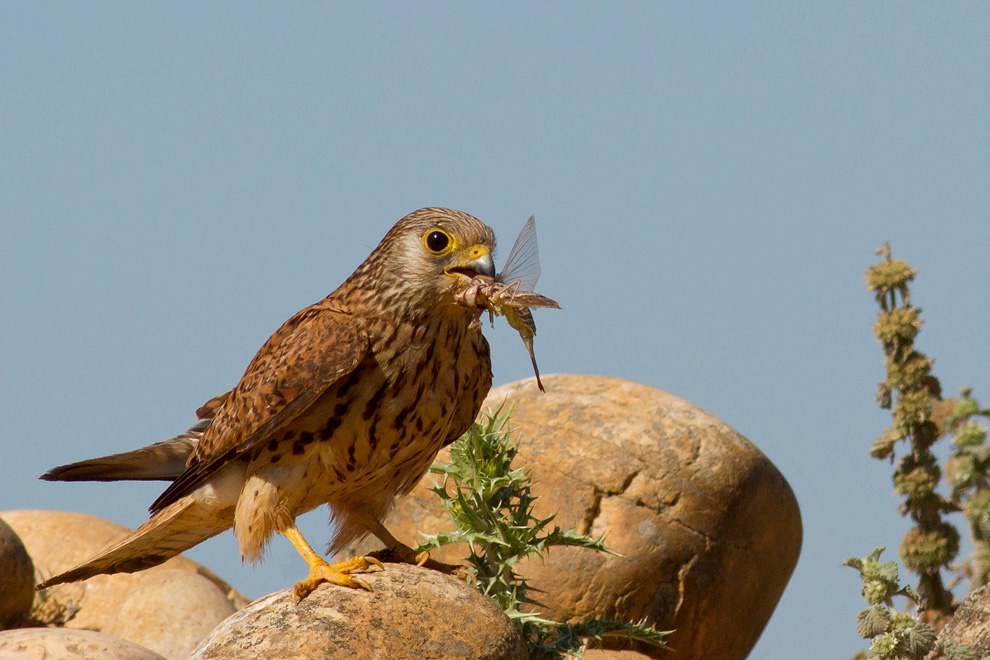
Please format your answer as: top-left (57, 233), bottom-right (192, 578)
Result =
top-left (189, 564), bottom-right (527, 660)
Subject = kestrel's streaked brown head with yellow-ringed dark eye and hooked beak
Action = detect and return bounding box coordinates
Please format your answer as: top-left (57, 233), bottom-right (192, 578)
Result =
top-left (353, 208), bottom-right (495, 308)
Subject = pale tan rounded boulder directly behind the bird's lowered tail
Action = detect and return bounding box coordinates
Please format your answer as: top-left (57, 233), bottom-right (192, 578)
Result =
top-left (0, 510), bottom-right (248, 657)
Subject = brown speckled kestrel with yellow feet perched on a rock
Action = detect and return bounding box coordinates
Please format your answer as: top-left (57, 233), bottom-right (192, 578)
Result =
top-left (38, 208), bottom-right (495, 602)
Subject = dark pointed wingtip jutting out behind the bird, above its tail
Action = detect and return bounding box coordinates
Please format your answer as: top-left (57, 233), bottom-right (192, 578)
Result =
top-left (40, 428), bottom-right (202, 481)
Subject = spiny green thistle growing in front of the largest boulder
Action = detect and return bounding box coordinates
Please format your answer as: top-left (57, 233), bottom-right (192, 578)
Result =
top-left (417, 409), bottom-right (670, 660)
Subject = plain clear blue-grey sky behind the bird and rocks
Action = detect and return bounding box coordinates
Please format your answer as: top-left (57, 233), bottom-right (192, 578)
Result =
top-left (0, 2), bottom-right (990, 658)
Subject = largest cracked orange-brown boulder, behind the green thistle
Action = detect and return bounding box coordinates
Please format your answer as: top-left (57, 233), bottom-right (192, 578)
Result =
top-left (344, 375), bottom-right (802, 660)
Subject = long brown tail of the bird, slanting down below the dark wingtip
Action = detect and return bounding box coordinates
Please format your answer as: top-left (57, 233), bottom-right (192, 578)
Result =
top-left (37, 497), bottom-right (233, 591)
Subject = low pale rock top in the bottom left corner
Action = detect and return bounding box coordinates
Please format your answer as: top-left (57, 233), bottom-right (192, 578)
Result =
top-left (0, 628), bottom-right (165, 660)
